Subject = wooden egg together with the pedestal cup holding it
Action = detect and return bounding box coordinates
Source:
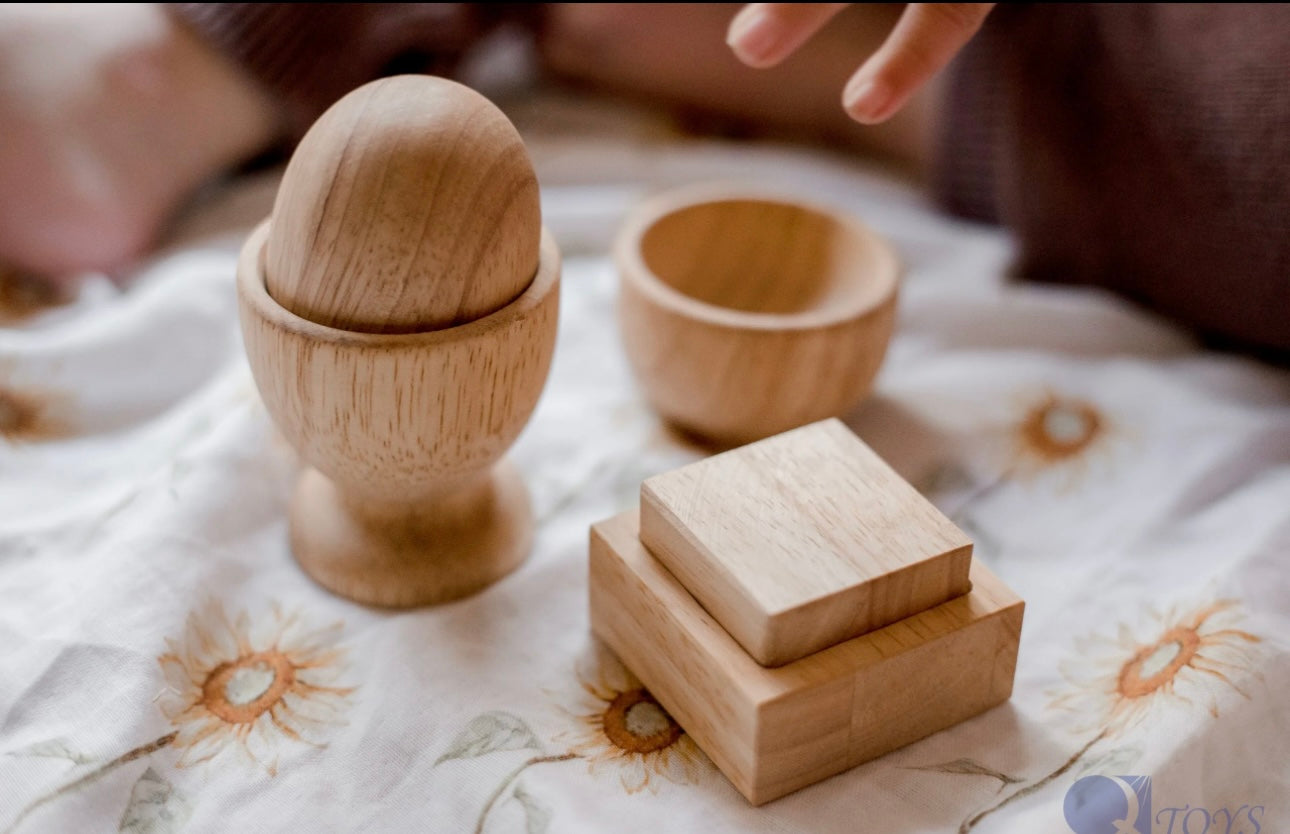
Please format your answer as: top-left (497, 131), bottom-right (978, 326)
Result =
top-left (237, 76), bottom-right (560, 606)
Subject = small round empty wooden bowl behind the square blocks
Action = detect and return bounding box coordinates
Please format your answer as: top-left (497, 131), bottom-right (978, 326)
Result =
top-left (614, 187), bottom-right (900, 446)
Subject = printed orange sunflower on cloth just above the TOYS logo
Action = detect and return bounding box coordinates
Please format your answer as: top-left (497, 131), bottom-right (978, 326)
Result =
top-left (1050, 599), bottom-right (1262, 735)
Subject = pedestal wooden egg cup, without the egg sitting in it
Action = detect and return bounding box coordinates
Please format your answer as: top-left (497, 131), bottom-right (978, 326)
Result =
top-left (237, 223), bottom-right (560, 607)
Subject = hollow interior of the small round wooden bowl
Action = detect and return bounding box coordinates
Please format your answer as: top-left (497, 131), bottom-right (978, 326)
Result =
top-left (640, 199), bottom-right (897, 315)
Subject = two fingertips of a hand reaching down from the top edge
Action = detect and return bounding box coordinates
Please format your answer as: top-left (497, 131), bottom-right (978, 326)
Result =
top-left (726, 3), bottom-right (995, 124)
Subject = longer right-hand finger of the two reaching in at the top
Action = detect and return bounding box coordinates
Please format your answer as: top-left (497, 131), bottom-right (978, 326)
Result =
top-left (842, 3), bottom-right (995, 124)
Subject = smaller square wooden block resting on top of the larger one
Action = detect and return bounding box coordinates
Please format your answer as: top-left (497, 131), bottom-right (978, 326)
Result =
top-left (641, 420), bottom-right (971, 666)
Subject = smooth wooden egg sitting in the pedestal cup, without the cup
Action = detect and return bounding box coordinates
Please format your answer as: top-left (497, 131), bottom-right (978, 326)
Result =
top-left (264, 75), bottom-right (542, 333)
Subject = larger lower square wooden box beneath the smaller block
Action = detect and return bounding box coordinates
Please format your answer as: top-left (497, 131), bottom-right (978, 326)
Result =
top-left (591, 510), bottom-right (1023, 804)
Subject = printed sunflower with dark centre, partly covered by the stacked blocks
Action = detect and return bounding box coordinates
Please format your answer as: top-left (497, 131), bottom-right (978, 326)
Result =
top-left (555, 656), bottom-right (712, 794)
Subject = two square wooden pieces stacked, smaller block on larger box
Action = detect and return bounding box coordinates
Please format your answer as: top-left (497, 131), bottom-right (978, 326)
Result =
top-left (591, 420), bottom-right (1023, 804)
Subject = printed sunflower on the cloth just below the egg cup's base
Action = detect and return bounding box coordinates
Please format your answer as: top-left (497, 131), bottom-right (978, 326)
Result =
top-left (157, 606), bottom-right (353, 776)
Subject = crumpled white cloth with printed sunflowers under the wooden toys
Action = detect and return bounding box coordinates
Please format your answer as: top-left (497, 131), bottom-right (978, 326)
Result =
top-left (0, 99), bottom-right (1290, 834)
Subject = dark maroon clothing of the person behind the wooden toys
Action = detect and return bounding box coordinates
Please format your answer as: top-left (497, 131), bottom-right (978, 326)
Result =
top-left (173, 4), bottom-right (1290, 361)
